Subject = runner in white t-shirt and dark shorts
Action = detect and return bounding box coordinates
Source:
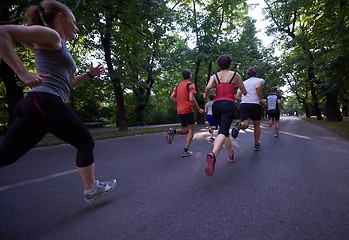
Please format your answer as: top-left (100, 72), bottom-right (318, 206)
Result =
top-left (232, 66), bottom-right (266, 151)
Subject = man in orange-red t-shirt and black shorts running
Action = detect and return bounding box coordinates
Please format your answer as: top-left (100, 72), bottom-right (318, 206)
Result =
top-left (166, 69), bottom-right (205, 157)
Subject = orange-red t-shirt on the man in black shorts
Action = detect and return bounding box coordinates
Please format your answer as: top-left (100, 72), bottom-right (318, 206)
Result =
top-left (174, 80), bottom-right (196, 114)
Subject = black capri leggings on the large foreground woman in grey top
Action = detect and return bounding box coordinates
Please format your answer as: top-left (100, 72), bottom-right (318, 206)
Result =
top-left (0, 92), bottom-right (94, 167)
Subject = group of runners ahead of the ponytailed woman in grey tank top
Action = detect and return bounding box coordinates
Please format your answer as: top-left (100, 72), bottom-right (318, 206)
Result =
top-left (166, 54), bottom-right (284, 176)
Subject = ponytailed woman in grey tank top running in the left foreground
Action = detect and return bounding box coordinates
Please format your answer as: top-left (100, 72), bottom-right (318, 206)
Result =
top-left (0, 0), bottom-right (117, 202)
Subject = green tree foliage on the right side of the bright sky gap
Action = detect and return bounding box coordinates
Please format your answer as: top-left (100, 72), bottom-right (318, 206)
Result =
top-left (265, 0), bottom-right (349, 120)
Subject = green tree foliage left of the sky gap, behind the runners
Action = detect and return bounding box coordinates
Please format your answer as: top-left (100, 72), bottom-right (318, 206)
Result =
top-left (0, 0), bottom-right (285, 129)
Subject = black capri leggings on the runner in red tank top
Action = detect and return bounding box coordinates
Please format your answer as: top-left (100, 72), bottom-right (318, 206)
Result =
top-left (212, 100), bottom-right (236, 137)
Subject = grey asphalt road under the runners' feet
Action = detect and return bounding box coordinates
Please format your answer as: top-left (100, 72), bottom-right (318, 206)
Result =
top-left (0, 117), bottom-right (349, 240)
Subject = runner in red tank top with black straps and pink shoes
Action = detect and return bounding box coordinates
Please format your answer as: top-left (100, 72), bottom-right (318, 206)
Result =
top-left (204, 54), bottom-right (247, 177)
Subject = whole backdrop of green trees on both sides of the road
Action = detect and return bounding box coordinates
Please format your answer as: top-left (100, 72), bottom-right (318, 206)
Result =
top-left (0, 0), bottom-right (349, 133)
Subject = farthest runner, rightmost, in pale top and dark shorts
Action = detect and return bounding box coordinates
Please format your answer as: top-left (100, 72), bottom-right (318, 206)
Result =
top-left (267, 87), bottom-right (284, 138)
